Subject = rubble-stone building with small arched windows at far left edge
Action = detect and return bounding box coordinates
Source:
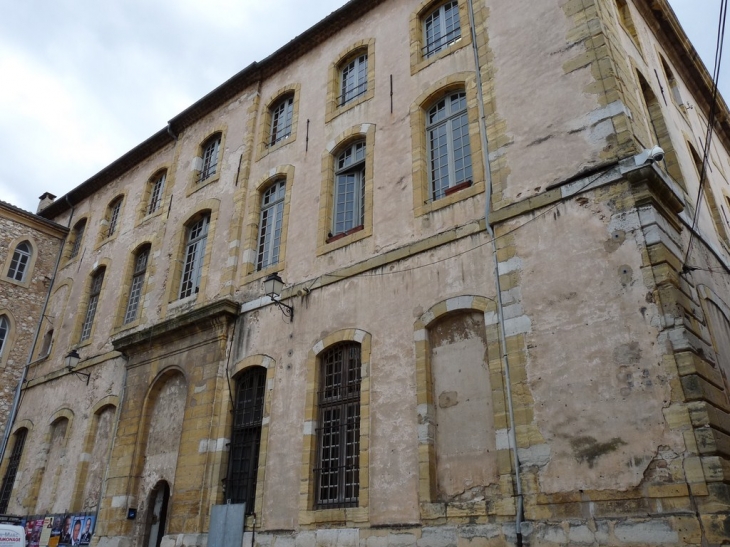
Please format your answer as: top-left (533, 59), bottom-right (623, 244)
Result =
top-left (0, 194), bottom-right (68, 488)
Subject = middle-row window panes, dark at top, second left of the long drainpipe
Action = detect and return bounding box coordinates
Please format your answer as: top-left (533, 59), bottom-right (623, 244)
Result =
top-left (330, 141), bottom-right (366, 237)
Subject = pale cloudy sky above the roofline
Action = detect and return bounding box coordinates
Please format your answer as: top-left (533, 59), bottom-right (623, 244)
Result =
top-left (0, 0), bottom-right (730, 211)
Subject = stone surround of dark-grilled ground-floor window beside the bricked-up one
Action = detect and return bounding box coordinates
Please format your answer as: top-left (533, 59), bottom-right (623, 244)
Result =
top-left (299, 328), bottom-right (372, 529)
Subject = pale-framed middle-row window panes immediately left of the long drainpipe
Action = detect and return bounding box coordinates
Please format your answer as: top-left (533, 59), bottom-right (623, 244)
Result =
top-left (426, 91), bottom-right (472, 200)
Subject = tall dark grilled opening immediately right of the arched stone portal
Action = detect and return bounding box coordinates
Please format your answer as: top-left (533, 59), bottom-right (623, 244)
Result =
top-left (226, 367), bottom-right (266, 514)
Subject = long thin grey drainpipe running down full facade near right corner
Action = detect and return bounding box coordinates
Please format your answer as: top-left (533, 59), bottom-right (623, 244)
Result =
top-left (467, 0), bottom-right (524, 547)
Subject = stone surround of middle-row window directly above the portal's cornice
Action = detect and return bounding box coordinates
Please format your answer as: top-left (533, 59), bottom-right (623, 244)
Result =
top-left (160, 198), bottom-right (220, 319)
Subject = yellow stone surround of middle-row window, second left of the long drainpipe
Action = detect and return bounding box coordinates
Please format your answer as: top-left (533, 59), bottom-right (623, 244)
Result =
top-left (317, 123), bottom-right (375, 256)
